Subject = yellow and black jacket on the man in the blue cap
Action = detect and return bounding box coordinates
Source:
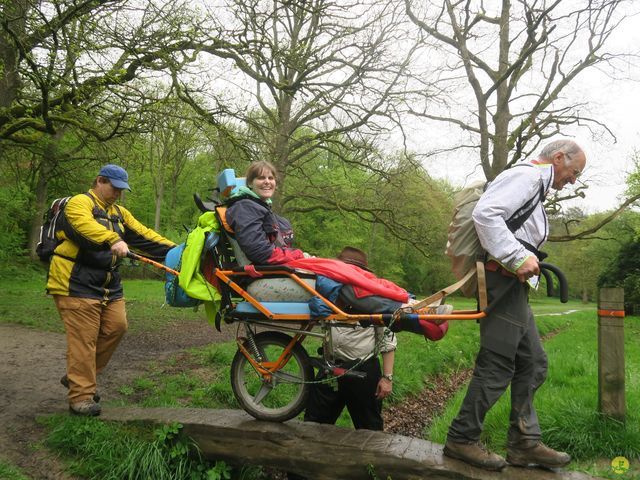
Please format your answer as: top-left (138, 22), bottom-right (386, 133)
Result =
top-left (47, 190), bottom-right (175, 301)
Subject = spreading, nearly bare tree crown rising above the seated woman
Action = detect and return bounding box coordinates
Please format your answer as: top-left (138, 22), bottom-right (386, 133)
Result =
top-left (175, 0), bottom-right (412, 208)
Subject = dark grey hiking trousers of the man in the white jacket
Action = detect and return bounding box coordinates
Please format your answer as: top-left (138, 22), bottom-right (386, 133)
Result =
top-left (447, 272), bottom-right (547, 445)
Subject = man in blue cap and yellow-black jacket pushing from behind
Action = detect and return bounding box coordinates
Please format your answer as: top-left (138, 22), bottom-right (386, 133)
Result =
top-left (47, 165), bottom-right (175, 416)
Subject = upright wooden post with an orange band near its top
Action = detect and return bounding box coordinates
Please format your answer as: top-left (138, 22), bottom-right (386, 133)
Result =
top-left (598, 288), bottom-right (625, 421)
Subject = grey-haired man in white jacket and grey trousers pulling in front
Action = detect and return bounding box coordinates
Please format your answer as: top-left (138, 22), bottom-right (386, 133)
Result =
top-left (444, 140), bottom-right (586, 470)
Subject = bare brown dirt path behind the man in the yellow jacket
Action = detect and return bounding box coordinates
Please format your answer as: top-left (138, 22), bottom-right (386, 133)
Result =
top-left (0, 321), bottom-right (233, 480)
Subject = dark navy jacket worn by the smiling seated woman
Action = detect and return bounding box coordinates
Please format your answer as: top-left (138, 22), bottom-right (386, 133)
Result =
top-left (227, 196), bottom-right (303, 265)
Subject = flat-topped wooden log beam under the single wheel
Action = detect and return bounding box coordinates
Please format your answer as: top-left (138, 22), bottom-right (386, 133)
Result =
top-left (100, 407), bottom-right (594, 480)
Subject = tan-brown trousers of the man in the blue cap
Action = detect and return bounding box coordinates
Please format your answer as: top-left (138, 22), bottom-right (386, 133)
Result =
top-left (53, 295), bottom-right (127, 403)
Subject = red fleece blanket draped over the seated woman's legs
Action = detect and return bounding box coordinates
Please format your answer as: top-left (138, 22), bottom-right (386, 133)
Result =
top-left (284, 258), bottom-right (409, 303)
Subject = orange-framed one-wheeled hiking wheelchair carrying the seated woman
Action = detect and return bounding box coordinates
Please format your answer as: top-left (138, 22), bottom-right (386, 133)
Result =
top-left (188, 169), bottom-right (567, 422)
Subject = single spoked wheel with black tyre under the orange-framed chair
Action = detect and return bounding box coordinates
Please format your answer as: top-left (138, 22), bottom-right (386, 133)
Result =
top-left (231, 332), bottom-right (313, 422)
